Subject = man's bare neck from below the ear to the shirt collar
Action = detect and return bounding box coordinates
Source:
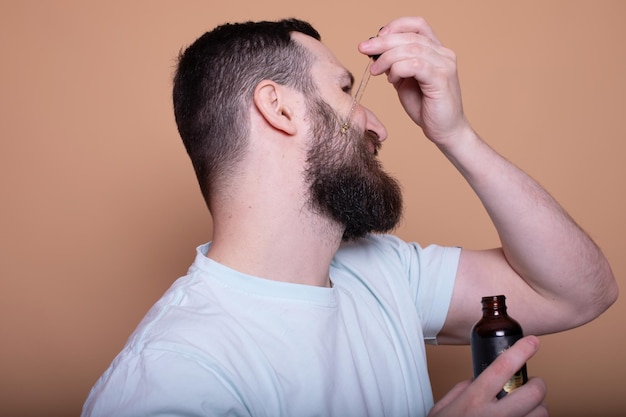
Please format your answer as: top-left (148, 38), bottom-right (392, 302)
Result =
top-left (207, 110), bottom-right (343, 287)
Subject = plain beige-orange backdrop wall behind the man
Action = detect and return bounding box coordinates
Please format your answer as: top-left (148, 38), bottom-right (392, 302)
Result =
top-left (0, 0), bottom-right (626, 417)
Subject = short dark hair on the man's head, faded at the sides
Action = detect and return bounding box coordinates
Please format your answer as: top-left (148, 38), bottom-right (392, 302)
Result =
top-left (173, 19), bottom-right (320, 204)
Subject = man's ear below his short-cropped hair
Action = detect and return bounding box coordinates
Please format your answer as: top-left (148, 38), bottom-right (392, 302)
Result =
top-left (254, 80), bottom-right (297, 135)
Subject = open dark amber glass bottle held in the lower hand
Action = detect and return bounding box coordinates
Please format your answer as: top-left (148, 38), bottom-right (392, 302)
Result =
top-left (470, 295), bottom-right (528, 399)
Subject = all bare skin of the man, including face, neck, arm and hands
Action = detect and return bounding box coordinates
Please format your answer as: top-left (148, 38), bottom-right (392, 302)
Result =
top-left (207, 18), bottom-right (618, 417)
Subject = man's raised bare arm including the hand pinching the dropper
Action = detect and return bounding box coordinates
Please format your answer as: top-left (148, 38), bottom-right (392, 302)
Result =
top-left (360, 14), bottom-right (618, 343)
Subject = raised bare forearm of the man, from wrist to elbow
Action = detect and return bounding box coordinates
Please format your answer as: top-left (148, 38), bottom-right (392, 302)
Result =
top-left (440, 128), bottom-right (617, 325)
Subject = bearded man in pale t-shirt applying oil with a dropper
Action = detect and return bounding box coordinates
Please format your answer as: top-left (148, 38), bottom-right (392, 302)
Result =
top-left (83, 17), bottom-right (617, 417)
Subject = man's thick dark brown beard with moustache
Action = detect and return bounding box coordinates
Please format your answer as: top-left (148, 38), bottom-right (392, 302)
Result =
top-left (306, 99), bottom-right (402, 240)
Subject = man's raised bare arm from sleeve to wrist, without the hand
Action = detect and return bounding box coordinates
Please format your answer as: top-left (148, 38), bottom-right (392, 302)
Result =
top-left (432, 128), bottom-right (617, 343)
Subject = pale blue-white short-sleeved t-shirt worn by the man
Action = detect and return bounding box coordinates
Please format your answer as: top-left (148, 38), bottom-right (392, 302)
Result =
top-left (82, 235), bottom-right (460, 417)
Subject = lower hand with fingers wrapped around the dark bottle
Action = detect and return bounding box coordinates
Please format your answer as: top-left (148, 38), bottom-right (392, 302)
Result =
top-left (428, 336), bottom-right (548, 417)
